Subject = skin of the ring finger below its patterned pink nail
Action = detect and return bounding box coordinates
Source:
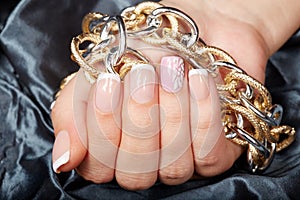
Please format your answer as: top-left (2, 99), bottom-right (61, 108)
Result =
top-left (159, 58), bottom-right (194, 185)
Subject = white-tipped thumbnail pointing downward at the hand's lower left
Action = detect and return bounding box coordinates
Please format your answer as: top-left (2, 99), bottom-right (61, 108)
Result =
top-left (52, 131), bottom-right (70, 173)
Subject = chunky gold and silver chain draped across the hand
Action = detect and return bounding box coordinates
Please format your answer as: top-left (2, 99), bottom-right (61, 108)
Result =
top-left (71, 2), bottom-right (295, 172)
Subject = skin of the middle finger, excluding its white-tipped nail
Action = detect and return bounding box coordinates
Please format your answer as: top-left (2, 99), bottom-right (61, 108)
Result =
top-left (115, 65), bottom-right (159, 190)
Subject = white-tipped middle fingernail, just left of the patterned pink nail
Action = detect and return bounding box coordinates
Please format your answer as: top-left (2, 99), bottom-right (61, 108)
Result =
top-left (130, 64), bottom-right (155, 104)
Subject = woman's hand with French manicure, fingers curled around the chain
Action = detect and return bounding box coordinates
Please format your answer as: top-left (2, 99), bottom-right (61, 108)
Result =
top-left (52, 1), bottom-right (298, 190)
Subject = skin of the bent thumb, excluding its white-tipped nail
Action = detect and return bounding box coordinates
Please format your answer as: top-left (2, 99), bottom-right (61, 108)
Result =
top-left (51, 70), bottom-right (90, 172)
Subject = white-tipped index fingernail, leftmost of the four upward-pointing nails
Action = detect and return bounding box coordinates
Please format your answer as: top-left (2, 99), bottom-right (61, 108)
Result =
top-left (95, 73), bottom-right (121, 113)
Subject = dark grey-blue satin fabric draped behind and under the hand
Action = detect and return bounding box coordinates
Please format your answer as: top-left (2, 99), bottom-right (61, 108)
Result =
top-left (0, 0), bottom-right (300, 199)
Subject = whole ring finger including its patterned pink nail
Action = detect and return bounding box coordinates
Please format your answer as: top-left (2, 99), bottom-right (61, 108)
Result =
top-left (159, 56), bottom-right (194, 185)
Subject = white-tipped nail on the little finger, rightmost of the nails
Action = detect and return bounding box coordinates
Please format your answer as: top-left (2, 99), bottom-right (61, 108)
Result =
top-left (189, 69), bottom-right (209, 101)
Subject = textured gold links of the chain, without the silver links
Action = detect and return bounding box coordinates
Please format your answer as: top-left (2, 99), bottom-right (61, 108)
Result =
top-left (67, 2), bottom-right (296, 169)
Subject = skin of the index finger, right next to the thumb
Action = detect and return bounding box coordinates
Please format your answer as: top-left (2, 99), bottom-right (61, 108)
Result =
top-left (77, 74), bottom-right (121, 183)
